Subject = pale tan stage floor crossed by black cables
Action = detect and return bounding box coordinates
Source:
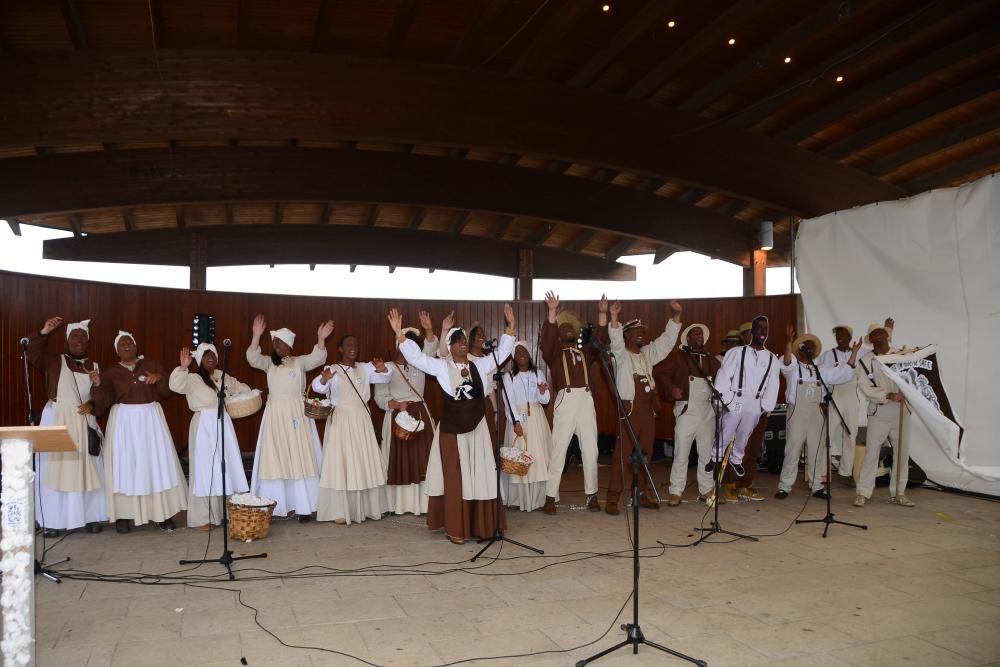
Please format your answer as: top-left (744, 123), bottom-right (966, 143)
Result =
top-left (27, 461), bottom-right (1000, 667)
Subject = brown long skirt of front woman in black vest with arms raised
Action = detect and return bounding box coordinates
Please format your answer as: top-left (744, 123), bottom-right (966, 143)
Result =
top-left (427, 432), bottom-right (507, 540)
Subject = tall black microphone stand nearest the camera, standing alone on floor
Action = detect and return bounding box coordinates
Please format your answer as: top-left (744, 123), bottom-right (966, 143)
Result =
top-left (576, 338), bottom-right (708, 667)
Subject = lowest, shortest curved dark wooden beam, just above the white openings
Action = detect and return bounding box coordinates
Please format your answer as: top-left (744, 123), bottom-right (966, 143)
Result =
top-left (42, 225), bottom-right (635, 280)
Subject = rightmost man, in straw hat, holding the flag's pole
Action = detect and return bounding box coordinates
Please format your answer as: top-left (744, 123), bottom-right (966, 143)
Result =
top-left (854, 318), bottom-right (915, 507)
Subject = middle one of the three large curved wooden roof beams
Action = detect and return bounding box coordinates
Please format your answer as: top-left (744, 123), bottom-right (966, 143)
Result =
top-left (0, 147), bottom-right (753, 265)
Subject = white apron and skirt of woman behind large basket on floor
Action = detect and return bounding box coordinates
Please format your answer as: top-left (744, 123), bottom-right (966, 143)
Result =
top-left (187, 408), bottom-right (250, 527)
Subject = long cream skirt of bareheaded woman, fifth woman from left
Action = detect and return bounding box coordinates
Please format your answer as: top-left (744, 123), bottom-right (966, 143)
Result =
top-left (316, 406), bottom-right (389, 524)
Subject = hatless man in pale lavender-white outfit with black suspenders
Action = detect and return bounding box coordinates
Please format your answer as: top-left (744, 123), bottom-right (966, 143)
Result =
top-left (705, 315), bottom-right (779, 486)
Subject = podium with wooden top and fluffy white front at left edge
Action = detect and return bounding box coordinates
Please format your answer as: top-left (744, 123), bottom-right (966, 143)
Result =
top-left (0, 426), bottom-right (76, 665)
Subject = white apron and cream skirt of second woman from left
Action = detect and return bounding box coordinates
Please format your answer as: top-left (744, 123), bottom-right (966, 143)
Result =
top-left (104, 403), bottom-right (188, 526)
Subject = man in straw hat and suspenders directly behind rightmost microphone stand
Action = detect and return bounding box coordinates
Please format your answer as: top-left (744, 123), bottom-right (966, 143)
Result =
top-left (774, 324), bottom-right (861, 500)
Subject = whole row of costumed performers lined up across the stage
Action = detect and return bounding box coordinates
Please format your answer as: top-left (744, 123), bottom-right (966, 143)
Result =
top-left (27, 302), bottom-right (913, 544)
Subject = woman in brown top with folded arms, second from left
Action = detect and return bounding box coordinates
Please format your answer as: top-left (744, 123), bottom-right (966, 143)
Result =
top-left (93, 331), bottom-right (188, 533)
